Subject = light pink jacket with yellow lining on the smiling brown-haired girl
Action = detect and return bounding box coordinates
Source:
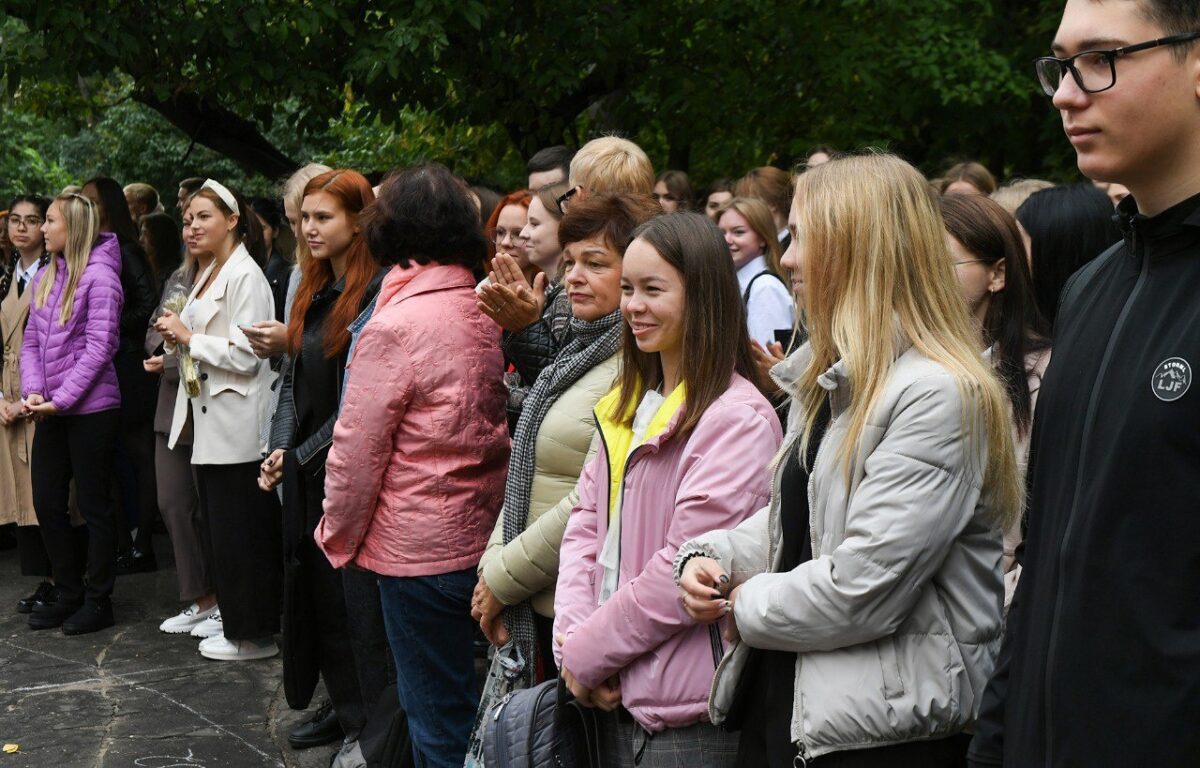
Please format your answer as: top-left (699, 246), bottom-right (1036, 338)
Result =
top-left (554, 374), bottom-right (782, 733)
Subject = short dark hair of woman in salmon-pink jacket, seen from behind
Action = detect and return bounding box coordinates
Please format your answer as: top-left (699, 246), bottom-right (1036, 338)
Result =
top-left (361, 163), bottom-right (487, 269)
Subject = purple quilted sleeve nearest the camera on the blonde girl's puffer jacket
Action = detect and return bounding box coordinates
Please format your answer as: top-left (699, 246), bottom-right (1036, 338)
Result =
top-left (50, 269), bottom-right (122, 412)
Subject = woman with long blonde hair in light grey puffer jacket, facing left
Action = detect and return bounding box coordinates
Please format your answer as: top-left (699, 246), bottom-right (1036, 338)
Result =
top-left (676, 155), bottom-right (1021, 768)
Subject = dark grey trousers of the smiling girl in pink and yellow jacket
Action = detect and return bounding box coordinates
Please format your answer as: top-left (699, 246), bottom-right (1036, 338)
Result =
top-left (600, 714), bottom-right (738, 768)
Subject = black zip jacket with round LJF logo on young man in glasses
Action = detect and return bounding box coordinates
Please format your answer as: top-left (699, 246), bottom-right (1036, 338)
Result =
top-left (970, 190), bottom-right (1200, 768)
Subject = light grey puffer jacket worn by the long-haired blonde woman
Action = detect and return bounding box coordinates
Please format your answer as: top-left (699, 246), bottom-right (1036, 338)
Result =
top-left (676, 344), bottom-right (1003, 758)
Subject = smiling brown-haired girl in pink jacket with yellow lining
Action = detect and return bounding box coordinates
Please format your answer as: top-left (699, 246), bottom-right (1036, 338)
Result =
top-left (554, 214), bottom-right (782, 767)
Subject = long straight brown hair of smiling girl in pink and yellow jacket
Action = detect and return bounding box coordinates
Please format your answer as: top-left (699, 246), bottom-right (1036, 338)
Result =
top-left (617, 212), bottom-right (758, 436)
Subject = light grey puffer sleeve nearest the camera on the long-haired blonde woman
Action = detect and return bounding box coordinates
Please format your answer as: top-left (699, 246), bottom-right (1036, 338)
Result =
top-left (734, 374), bottom-right (998, 653)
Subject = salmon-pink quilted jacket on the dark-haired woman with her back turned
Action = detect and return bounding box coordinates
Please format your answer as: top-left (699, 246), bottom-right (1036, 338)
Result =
top-left (314, 264), bottom-right (509, 576)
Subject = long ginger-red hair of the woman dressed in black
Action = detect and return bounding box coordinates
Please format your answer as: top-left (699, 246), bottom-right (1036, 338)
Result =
top-left (288, 168), bottom-right (379, 358)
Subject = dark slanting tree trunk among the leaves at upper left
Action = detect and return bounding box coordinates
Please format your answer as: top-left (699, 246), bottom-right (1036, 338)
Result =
top-left (133, 91), bottom-right (300, 179)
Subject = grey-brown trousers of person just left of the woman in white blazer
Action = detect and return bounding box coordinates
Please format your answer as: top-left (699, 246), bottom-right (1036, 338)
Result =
top-left (154, 433), bottom-right (212, 602)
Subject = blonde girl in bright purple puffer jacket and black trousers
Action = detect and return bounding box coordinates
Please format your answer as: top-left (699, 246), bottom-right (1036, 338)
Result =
top-left (20, 194), bottom-right (124, 635)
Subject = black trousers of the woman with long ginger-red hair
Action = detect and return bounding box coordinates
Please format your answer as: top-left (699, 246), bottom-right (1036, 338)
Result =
top-left (283, 451), bottom-right (364, 738)
